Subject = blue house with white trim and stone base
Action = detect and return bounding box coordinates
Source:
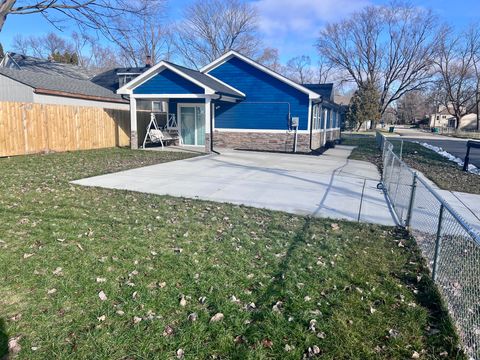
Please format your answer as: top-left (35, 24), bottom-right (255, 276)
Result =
top-left (117, 51), bottom-right (340, 152)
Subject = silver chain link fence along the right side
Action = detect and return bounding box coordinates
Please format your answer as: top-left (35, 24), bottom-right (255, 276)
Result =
top-left (377, 132), bottom-right (480, 359)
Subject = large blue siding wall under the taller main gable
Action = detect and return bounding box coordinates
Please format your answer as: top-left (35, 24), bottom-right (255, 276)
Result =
top-left (209, 57), bottom-right (309, 130)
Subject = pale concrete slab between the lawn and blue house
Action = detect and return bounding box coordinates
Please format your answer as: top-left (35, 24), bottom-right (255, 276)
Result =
top-left (73, 146), bottom-right (394, 225)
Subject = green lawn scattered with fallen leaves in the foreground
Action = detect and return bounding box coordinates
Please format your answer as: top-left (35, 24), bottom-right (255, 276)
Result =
top-left (0, 149), bottom-right (463, 359)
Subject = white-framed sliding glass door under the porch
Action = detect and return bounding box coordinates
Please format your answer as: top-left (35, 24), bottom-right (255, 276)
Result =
top-left (179, 104), bottom-right (205, 145)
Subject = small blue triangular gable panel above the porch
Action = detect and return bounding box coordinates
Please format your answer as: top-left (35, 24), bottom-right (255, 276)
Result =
top-left (133, 69), bottom-right (205, 94)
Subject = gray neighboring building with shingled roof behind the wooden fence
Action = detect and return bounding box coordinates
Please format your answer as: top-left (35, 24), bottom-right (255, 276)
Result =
top-left (0, 53), bottom-right (129, 110)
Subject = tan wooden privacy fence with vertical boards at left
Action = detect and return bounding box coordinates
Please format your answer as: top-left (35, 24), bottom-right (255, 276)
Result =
top-left (0, 102), bottom-right (130, 156)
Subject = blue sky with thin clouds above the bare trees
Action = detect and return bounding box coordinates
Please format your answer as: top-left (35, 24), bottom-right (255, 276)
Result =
top-left (0, 0), bottom-right (480, 62)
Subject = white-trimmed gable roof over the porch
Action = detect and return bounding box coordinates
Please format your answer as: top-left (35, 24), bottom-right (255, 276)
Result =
top-left (117, 61), bottom-right (245, 97)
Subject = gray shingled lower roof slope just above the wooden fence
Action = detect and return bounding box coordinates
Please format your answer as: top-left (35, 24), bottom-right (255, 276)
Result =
top-left (0, 67), bottom-right (126, 102)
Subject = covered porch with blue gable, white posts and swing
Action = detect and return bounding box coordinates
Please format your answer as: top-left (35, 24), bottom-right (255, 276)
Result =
top-left (117, 61), bottom-right (245, 152)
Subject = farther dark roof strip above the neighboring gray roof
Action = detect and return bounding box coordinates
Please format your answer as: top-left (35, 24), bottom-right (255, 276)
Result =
top-left (0, 52), bottom-right (94, 80)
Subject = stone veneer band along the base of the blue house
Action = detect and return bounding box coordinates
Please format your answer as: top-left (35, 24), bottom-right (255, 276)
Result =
top-left (205, 130), bottom-right (340, 152)
